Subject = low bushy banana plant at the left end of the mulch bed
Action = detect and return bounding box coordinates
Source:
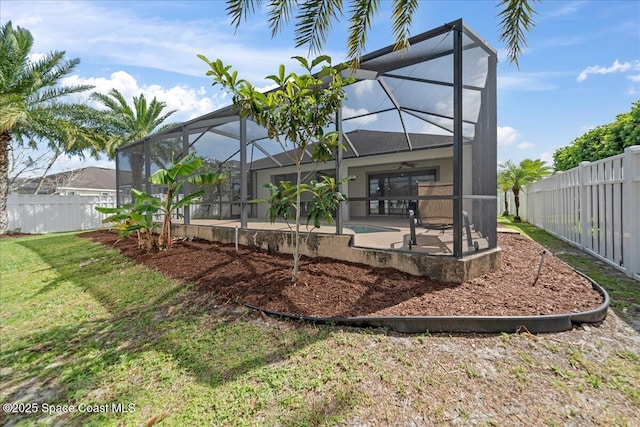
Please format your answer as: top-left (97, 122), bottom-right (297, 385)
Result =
top-left (96, 188), bottom-right (162, 250)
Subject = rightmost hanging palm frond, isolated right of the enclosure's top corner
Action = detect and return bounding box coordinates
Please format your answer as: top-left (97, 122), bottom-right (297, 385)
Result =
top-left (498, 0), bottom-right (539, 67)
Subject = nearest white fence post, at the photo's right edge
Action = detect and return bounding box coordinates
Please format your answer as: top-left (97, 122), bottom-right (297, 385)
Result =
top-left (622, 145), bottom-right (640, 277)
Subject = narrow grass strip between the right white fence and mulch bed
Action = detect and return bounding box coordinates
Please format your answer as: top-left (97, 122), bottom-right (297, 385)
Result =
top-left (498, 217), bottom-right (640, 329)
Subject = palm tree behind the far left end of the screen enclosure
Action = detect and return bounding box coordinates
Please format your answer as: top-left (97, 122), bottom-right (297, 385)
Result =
top-left (91, 89), bottom-right (176, 194)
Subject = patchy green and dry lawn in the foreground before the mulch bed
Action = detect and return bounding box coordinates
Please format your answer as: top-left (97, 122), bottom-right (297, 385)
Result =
top-left (0, 233), bottom-right (640, 426)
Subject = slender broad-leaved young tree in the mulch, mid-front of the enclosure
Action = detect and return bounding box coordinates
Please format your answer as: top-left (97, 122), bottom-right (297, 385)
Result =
top-left (198, 55), bottom-right (352, 282)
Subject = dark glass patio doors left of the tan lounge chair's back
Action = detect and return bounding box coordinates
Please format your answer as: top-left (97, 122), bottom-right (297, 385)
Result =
top-left (369, 169), bottom-right (437, 215)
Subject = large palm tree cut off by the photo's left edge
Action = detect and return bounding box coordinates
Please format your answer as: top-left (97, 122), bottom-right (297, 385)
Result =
top-left (0, 21), bottom-right (102, 234)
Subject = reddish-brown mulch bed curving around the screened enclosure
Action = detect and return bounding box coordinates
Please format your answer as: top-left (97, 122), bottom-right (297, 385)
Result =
top-left (81, 230), bottom-right (603, 317)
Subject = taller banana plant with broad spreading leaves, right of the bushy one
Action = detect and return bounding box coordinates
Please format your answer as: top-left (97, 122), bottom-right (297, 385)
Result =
top-left (149, 153), bottom-right (226, 249)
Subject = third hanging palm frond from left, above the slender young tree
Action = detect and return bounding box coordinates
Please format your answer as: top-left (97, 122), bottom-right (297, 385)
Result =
top-left (295, 0), bottom-right (342, 53)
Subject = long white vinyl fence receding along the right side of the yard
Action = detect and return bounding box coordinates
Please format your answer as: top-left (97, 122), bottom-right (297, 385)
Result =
top-left (499, 145), bottom-right (640, 280)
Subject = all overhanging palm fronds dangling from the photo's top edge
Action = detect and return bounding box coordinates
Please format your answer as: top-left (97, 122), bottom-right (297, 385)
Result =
top-left (227, 0), bottom-right (539, 65)
